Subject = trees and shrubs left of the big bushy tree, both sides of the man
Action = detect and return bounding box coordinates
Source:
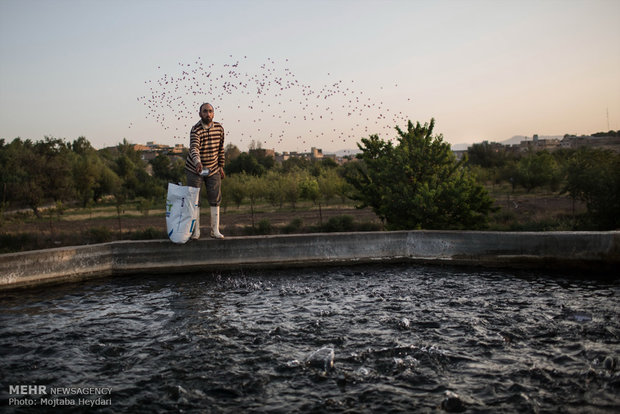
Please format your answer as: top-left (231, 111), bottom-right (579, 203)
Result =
top-left (0, 137), bottom-right (346, 220)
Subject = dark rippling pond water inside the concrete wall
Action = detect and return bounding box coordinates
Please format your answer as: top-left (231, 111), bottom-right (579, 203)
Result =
top-left (0, 265), bottom-right (620, 413)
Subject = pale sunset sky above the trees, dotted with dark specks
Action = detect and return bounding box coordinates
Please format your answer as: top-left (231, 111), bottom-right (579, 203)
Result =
top-left (0, 0), bottom-right (620, 153)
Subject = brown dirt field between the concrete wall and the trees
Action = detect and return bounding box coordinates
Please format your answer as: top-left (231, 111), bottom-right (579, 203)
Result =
top-left (0, 186), bottom-right (585, 253)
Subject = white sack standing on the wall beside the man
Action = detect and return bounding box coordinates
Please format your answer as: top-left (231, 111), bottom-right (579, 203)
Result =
top-left (166, 183), bottom-right (200, 244)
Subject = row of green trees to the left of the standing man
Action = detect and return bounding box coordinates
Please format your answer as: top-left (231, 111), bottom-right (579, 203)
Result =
top-left (0, 137), bottom-right (183, 220)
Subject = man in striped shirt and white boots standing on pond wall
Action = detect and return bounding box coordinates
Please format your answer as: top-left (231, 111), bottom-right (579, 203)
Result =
top-left (185, 103), bottom-right (225, 239)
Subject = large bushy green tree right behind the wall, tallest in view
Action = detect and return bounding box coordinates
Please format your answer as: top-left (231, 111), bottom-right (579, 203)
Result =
top-left (346, 119), bottom-right (493, 230)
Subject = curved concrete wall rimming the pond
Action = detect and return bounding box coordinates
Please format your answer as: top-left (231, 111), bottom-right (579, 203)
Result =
top-left (0, 231), bottom-right (620, 290)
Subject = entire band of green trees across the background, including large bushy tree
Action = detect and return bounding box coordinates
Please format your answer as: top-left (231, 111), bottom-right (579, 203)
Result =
top-left (0, 120), bottom-right (620, 233)
